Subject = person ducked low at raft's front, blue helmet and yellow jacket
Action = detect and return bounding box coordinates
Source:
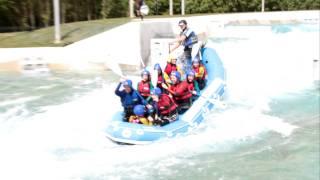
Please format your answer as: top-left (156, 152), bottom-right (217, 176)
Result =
top-left (129, 104), bottom-right (152, 126)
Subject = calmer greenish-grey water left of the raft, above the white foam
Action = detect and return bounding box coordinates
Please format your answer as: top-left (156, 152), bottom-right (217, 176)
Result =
top-left (0, 72), bottom-right (116, 120)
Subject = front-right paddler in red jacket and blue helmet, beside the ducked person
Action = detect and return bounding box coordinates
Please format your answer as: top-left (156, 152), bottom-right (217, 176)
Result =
top-left (147, 87), bottom-right (178, 126)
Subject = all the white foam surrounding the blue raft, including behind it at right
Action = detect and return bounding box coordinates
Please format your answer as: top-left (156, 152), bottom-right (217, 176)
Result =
top-left (0, 23), bottom-right (319, 180)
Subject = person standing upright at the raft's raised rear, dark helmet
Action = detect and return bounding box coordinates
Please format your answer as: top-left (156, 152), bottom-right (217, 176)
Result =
top-left (169, 20), bottom-right (198, 72)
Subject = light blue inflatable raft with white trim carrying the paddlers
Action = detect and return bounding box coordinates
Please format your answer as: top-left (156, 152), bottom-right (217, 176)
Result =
top-left (105, 47), bottom-right (225, 144)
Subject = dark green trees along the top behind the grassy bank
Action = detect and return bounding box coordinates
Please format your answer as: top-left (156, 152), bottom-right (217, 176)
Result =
top-left (0, 0), bottom-right (320, 32)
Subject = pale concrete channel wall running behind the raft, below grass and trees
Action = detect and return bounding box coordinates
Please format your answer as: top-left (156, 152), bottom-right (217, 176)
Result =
top-left (0, 11), bottom-right (320, 71)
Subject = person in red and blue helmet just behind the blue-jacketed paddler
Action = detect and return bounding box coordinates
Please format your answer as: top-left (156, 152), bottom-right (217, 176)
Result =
top-left (137, 70), bottom-right (153, 101)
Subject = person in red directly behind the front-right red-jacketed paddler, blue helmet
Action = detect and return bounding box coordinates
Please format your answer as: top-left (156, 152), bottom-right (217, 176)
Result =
top-left (164, 71), bottom-right (192, 114)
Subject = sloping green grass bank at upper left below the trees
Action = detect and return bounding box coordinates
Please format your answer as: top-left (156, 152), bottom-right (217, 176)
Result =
top-left (0, 18), bottom-right (130, 48)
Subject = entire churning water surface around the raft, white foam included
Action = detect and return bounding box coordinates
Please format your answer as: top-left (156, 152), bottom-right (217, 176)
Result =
top-left (0, 25), bottom-right (320, 180)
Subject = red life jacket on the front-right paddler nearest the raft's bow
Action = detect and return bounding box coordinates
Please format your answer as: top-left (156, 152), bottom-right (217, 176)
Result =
top-left (157, 94), bottom-right (178, 115)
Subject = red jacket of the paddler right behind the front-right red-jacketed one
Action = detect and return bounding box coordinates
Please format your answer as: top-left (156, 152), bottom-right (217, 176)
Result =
top-left (169, 81), bottom-right (192, 100)
